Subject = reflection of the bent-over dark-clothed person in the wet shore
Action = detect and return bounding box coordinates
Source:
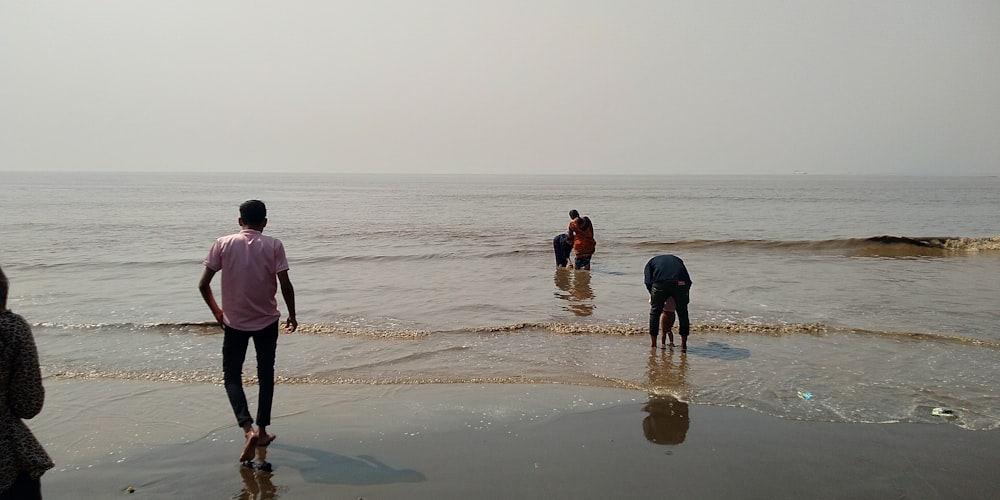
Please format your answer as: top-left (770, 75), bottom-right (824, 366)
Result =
top-left (642, 348), bottom-right (691, 444)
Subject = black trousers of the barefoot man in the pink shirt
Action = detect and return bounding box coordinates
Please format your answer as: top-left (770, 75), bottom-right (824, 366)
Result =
top-left (222, 321), bottom-right (278, 427)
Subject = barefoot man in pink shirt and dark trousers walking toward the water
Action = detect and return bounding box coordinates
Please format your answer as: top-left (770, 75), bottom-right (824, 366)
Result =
top-left (198, 200), bottom-right (298, 462)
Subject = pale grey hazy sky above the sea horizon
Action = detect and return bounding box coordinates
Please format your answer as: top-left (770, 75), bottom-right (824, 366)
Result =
top-left (0, 0), bottom-right (1000, 175)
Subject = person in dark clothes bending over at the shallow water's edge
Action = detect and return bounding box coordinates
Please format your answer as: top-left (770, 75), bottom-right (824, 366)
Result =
top-left (643, 254), bottom-right (691, 352)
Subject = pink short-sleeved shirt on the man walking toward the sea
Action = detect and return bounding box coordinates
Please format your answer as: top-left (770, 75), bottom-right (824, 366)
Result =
top-left (205, 229), bottom-right (288, 332)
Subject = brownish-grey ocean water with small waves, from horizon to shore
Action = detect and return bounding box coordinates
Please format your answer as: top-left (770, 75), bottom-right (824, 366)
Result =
top-left (0, 172), bottom-right (1000, 430)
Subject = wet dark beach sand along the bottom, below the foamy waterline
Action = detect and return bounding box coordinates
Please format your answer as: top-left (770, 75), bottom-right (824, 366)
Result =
top-left (28, 378), bottom-right (1000, 499)
